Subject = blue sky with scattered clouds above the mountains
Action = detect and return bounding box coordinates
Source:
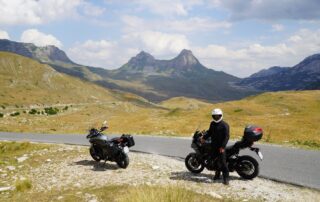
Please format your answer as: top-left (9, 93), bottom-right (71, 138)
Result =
top-left (0, 0), bottom-right (320, 77)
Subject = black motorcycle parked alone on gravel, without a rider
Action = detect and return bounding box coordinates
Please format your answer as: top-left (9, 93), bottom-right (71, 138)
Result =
top-left (87, 127), bottom-right (135, 168)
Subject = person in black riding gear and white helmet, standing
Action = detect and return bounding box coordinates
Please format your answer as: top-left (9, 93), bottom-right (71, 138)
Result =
top-left (201, 108), bottom-right (230, 185)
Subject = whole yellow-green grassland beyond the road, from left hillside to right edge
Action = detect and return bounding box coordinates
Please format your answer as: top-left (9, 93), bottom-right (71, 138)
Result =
top-left (0, 53), bottom-right (320, 148)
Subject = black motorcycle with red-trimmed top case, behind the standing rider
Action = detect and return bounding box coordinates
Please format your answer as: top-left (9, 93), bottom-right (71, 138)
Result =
top-left (185, 126), bottom-right (263, 179)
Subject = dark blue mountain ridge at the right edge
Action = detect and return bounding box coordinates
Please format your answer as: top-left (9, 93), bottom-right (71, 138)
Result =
top-left (238, 54), bottom-right (320, 91)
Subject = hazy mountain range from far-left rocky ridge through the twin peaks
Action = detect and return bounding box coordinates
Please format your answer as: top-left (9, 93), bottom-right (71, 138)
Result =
top-left (0, 40), bottom-right (258, 102)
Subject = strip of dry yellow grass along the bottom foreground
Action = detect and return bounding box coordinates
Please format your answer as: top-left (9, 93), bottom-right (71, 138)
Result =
top-left (3, 185), bottom-right (222, 202)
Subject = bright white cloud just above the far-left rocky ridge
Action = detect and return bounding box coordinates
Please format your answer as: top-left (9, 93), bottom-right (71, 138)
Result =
top-left (20, 29), bottom-right (62, 48)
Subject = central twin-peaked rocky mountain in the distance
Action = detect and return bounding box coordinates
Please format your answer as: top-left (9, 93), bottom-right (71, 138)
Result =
top-left (102, 50), bottom-right (256, 102)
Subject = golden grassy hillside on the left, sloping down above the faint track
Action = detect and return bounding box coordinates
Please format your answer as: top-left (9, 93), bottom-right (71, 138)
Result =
top-left (0, 52), bottom-right (154, 106)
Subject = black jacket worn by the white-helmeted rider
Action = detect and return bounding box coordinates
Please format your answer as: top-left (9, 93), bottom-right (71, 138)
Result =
top-left (203, 120), bottom-right (229, 148)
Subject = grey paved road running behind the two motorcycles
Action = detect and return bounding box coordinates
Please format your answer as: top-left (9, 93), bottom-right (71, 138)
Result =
top-left (0, 132), bottom-right (320, 190)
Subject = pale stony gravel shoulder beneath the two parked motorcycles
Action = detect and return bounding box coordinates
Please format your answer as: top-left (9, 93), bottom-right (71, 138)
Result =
top-left (0, 145), bottom-right (320, 201)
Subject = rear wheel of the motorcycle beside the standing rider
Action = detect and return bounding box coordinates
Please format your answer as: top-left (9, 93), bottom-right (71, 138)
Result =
top-left (236, 156), bottom-right (259, 180)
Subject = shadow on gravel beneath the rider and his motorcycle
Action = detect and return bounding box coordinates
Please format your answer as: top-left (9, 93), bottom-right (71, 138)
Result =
top-left (170, 171), bottom-right (245, 183)
